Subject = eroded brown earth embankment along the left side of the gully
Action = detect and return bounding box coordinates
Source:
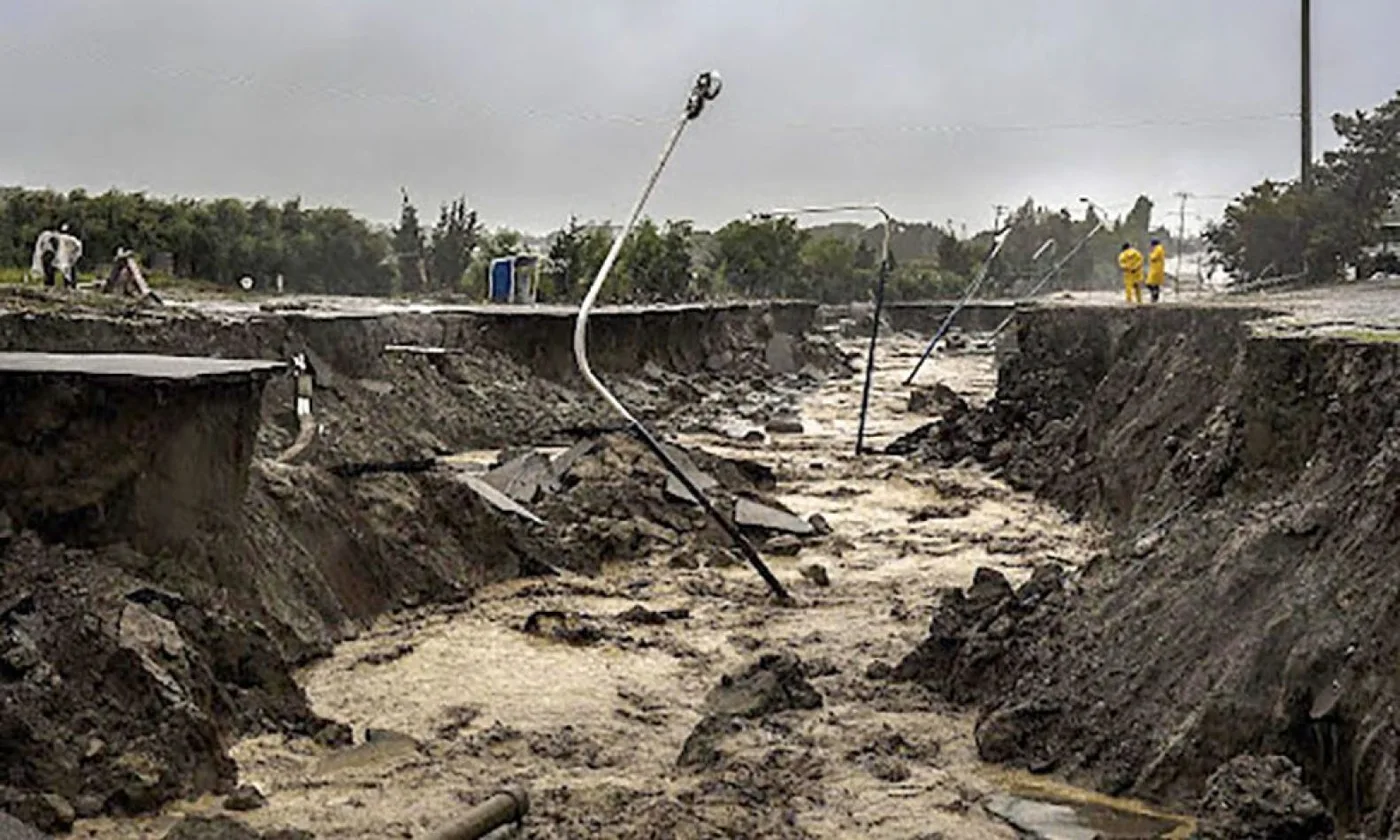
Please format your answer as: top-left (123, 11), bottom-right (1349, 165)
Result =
top-left (0, 292), bottom-right (839, 830)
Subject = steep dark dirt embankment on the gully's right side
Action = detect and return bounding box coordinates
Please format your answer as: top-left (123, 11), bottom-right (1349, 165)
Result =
top-left (906, 308), bottom-right (1400, 836)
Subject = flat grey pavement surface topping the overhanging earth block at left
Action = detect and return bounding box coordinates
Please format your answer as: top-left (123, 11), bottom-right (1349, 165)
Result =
top-left (0, 353), bottom-right (287, 381)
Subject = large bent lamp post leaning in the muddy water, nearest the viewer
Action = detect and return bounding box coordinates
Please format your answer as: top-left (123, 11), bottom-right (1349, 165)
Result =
top-left (574, 71), bottom-right (792, 603)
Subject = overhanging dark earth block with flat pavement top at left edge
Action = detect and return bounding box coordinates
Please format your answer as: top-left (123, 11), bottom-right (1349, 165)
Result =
top-left (0, 353), bottom-right (280, 553)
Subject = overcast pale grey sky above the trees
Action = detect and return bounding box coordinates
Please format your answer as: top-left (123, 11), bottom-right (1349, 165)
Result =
top-left (0, 0), bottom-right (1400, 232)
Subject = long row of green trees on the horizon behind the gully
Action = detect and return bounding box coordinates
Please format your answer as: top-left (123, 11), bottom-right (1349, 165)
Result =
top-left (0, 178), bottom-right (1192, 304)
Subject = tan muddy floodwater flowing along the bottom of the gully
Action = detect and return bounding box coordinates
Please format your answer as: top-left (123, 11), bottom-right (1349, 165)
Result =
top-left (77, 337), bottom-right (1175, 840)
